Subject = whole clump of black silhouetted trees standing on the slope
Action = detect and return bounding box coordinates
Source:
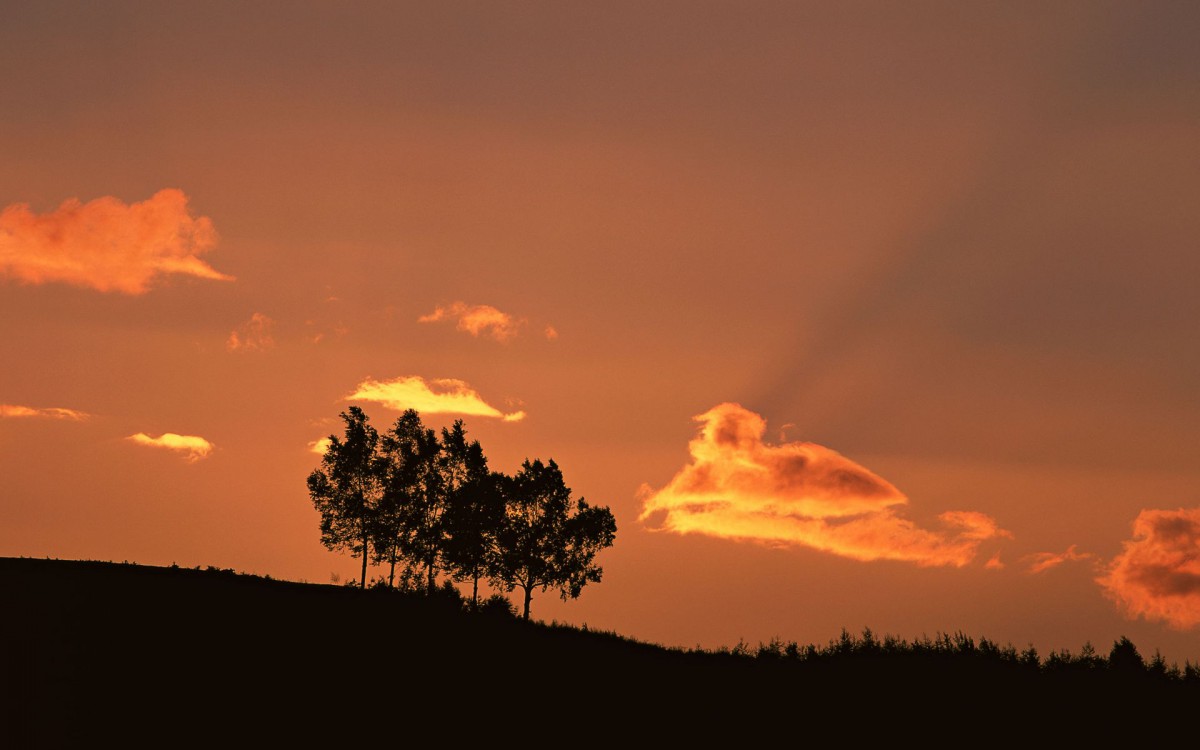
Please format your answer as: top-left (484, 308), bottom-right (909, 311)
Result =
top-left (308, 406), bottom-right (617, 619)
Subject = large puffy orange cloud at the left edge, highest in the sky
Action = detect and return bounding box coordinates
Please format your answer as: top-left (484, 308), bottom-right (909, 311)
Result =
top-left (0, 190), bottom-right (233, 294)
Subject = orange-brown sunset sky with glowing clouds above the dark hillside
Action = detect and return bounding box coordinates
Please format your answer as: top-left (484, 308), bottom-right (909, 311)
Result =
top-left (7, 1), bottom-right (1200, 664)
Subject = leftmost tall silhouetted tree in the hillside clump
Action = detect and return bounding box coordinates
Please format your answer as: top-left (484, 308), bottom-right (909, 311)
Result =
top-left (308, 407), bottom-right (383, 588)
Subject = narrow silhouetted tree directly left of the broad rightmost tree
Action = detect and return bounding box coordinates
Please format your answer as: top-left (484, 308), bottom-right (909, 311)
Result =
top-left (442, 421), bottom-right (504, 608)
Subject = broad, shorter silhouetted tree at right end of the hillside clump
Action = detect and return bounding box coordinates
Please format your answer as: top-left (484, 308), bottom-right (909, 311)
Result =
top-left (492, 460), bottom-right (617, 619)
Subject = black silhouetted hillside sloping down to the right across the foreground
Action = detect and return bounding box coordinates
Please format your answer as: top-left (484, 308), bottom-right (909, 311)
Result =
top-left (0, 558), bottom-right (1200, 748)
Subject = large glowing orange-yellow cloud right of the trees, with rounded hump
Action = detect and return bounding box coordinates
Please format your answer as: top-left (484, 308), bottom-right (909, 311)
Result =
top-left (638, 403), bottom-right (1009, 566)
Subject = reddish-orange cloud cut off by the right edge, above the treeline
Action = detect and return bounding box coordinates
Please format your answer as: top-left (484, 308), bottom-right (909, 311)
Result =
top-left (1096, 508), bottom-right (1200, 630)
